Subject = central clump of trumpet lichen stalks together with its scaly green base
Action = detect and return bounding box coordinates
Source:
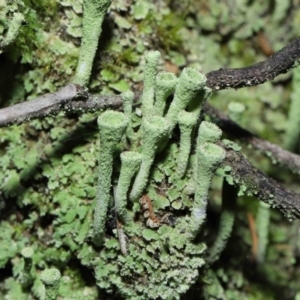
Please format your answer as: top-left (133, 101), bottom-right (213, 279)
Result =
top-left (93, 51), bottom-right (225, 299)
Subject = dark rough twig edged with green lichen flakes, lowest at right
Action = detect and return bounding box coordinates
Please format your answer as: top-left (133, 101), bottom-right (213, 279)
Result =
top-left (219, 142), bottom-right (300, 219)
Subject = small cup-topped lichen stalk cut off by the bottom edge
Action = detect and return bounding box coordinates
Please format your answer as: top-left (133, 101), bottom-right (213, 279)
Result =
top-left (41, 268), bottom-right (60, 300)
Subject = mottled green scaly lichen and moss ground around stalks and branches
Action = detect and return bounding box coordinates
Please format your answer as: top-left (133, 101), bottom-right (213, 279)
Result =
top-left (0, 0), bottom-right (300, 300)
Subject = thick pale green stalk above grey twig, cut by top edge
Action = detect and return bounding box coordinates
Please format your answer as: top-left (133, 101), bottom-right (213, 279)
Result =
top-left (73, 0), bottom-right (111, 86)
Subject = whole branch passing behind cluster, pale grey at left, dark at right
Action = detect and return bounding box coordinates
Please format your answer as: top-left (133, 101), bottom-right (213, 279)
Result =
top-left (0, 37), bottom-right (300, 127)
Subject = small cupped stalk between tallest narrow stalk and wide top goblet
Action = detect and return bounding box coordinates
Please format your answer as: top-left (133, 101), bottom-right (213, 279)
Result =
top-left (153, 72), bottom-right (177, 116)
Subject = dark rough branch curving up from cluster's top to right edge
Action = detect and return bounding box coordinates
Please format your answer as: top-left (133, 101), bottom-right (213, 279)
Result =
top-left (206, 37), bottom-right (300, 91)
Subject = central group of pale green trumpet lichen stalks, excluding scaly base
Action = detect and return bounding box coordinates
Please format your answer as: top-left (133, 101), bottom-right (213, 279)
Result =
top-left (93, 51), bottom-right (225, 254)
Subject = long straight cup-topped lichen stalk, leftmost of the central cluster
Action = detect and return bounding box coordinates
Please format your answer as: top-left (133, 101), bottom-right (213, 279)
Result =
top-left (94, 110), bottom-right (127, 245)
